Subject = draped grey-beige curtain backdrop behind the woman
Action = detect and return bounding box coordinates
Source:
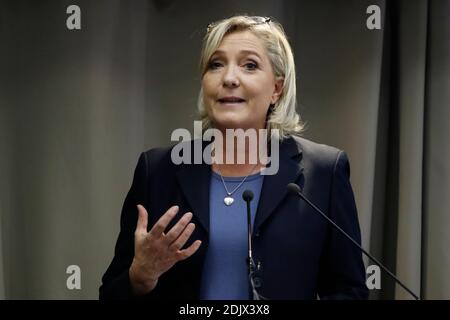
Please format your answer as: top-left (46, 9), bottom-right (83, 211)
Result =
top-left (0, 0), bottom-right (450, 299)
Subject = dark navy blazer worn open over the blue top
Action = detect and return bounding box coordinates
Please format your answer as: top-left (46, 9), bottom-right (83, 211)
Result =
top-left (100, 137), bottom-right (368, 299)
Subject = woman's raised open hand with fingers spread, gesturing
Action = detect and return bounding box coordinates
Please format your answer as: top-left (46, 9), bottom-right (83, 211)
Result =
top-left (129, 205), bottom-right (201, 294)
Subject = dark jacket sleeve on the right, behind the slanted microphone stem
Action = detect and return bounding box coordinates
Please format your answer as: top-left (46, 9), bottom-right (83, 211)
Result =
top-left (318, 151), bottom-right (369, 300)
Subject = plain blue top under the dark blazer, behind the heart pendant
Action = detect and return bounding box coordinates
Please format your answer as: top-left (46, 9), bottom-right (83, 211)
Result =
top-left (200, 172), bottom-right (264, 300)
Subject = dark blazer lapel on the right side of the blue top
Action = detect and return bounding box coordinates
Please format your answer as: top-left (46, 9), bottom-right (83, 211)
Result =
top-left (253, 138), bottom-right (303, 231)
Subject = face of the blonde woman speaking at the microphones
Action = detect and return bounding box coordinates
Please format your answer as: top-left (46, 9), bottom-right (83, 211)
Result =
top-left (202, 31), bottom-right (283, 130)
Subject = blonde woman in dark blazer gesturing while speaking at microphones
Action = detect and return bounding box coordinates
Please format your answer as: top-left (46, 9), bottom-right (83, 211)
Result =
top-left (100, 16), bottom-right (368, 299)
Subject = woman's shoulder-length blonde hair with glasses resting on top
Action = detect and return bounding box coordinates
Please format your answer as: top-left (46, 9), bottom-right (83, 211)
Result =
top-left (197, 16), bottom-right (303, 139)
